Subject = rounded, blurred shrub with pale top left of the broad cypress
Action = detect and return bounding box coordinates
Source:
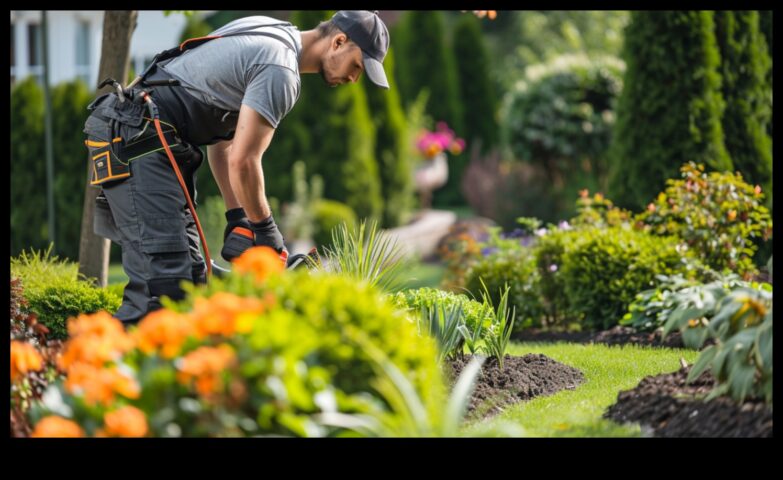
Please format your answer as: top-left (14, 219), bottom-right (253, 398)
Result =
top-left (502, 54), bottom-right (625, 210)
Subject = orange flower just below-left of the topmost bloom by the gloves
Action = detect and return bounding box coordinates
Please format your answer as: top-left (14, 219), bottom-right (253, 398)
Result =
top-left (190, 292), bottom-right (265, 338)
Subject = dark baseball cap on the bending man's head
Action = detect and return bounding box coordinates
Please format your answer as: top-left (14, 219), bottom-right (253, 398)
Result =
top-left (332, 10), bottom-right (389, 88)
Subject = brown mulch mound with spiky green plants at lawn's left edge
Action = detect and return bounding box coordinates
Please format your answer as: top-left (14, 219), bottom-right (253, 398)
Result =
top-left (447, 354), bottom-right (584, 420)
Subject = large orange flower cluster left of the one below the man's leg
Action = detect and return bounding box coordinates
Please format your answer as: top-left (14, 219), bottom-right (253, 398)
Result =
top-left (58, 311), bottom-right (134, 371)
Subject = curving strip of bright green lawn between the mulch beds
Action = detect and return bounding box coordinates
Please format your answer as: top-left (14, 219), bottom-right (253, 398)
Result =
top-left (465, 343), bottom-right (699, 437)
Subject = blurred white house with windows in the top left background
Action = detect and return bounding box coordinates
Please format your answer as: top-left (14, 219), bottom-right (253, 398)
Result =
top-left (11, 10), bottom-right (211, 88)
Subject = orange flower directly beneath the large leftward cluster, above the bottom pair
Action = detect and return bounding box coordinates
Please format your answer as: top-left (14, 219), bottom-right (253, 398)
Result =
top-left (65, 363), bottom-right (141, 405)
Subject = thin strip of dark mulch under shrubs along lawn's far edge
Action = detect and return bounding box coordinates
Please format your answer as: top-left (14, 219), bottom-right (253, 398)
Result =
top-left (512, 325), bottom-right (715, 348)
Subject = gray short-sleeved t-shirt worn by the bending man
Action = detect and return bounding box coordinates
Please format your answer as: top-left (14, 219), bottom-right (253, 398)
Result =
top-left (161, 16), bottom-right (302, 128)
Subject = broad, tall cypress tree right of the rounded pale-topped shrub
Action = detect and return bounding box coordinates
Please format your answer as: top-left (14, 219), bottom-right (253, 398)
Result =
top-left (609, 11), bottom-right (732, 209)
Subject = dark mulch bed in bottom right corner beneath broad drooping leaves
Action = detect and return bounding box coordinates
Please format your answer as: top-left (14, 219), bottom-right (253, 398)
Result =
top-left (604, 366), bottom-right (772, 437)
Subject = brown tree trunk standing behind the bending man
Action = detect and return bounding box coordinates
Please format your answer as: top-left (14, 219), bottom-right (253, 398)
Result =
top-left (79, 10), bottom-right (138, 287)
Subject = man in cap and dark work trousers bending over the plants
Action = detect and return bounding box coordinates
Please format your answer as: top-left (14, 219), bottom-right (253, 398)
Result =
top-left (84, 11), bottom-right (389, 325)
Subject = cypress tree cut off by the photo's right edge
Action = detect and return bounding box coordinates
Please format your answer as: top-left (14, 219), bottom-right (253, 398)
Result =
top-left (715, 11), bottom-right (772, 205)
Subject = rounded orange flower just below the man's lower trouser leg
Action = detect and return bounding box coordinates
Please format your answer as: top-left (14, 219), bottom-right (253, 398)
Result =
top-left (133, 308), bottom-right (193, 358)
